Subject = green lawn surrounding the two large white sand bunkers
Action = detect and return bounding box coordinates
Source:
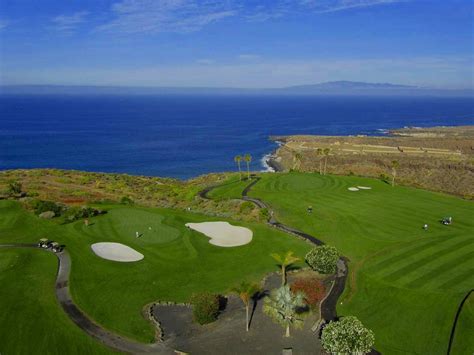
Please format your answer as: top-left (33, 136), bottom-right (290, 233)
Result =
top-left (0, 201), bottom-right (310, 350)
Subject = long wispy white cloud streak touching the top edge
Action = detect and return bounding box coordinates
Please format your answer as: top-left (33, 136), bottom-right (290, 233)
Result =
top-left (98, 0), bottom-right (409, 33)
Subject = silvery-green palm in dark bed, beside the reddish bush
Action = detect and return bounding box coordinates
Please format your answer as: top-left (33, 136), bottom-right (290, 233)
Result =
top-left (263, 285), bottom-right (305, 337)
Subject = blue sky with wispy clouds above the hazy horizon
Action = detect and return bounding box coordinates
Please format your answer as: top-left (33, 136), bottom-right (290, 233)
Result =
top-left (0, 0), bottom-right (474, 89)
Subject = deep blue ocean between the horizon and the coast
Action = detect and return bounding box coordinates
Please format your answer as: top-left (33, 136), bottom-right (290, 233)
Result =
top-left (0, 95), bottom-right (474, 179)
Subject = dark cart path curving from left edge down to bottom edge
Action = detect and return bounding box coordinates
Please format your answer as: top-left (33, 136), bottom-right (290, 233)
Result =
top-left (0, 243), bottom-right (170, 354)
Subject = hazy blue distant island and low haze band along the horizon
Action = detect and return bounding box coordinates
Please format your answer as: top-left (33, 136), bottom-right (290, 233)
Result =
top-left (0, 81), bottom-right (474, 97)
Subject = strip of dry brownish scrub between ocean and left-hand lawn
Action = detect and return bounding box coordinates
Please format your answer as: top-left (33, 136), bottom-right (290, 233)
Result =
top-left (0, 169), bottom-right (259, 220)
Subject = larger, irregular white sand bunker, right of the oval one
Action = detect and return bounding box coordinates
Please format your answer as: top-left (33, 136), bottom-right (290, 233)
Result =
top-left (186, 222), bottom-right (253, 247)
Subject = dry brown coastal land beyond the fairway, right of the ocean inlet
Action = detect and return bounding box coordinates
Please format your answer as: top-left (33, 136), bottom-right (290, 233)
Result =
top-left (273, 126), bottom-right (474, 199)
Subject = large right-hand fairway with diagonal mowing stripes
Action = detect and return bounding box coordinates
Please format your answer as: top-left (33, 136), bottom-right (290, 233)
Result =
top-left (246, 173), bottom-right (474, 354)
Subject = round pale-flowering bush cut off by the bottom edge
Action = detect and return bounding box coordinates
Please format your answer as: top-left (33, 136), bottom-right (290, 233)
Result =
top-left (321, 316), bottom-right (375, 354)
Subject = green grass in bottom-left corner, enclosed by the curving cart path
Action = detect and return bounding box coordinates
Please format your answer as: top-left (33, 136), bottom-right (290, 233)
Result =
top-left (0, 248), bottom-right (112, 354)
